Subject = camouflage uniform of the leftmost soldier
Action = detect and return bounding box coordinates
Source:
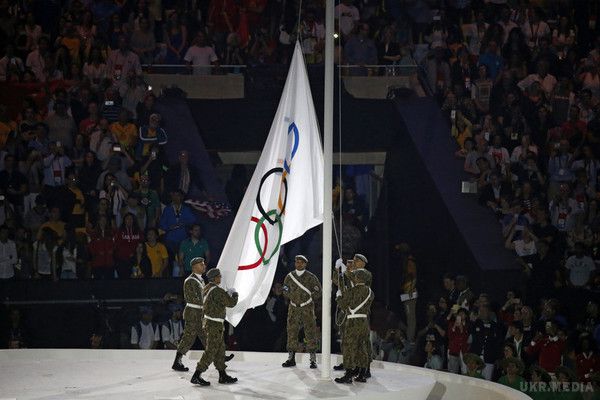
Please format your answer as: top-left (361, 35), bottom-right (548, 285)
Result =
top-left (177, 273), bottom-right (206, 354)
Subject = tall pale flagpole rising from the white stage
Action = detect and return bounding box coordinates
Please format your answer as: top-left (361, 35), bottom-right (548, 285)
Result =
top-left (321, 0), bottom-right (334, 380)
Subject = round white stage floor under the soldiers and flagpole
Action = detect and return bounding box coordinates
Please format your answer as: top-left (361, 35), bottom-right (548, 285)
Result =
top-left (0, 349), bottom-right (528, 400)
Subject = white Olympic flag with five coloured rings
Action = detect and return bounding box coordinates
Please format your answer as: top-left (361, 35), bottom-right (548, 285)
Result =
top-left (218, 43), bottom-right (323, 326)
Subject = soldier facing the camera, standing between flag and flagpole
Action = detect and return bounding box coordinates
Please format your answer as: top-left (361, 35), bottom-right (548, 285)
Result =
top-left (281, 255), bottom-right (321, 368)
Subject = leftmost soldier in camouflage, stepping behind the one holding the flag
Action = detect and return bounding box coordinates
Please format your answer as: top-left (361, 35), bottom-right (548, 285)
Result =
top-left (172, 257), bottom-right (206, 371)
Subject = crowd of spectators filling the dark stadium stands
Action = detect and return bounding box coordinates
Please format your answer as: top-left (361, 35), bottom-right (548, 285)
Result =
top-left (0, 0), bottom-right (600, 398)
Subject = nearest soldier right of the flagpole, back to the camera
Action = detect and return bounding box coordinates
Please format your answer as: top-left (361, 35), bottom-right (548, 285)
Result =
top-left (335, 264), bottom-right (374, 383)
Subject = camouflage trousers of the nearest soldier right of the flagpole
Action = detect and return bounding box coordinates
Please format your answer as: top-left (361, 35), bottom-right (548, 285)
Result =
top-left (342, 318), bottom-right (371, 369)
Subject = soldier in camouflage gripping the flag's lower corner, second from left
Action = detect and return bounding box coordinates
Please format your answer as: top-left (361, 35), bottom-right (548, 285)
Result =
top-left (191, 268), bottom-right (238, 386)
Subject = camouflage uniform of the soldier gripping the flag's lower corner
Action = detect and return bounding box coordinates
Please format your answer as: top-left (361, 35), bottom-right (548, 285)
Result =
top-left (196, 282), bottom-right (238, 373)
